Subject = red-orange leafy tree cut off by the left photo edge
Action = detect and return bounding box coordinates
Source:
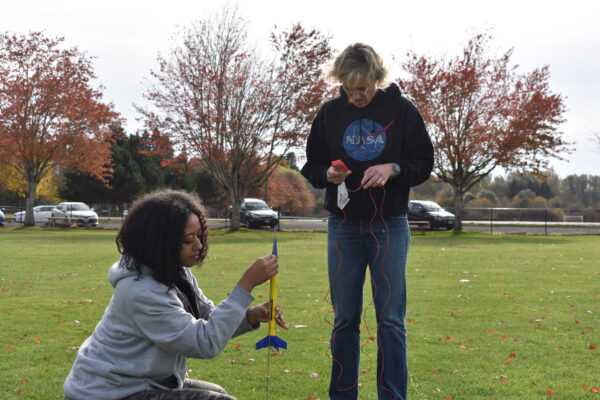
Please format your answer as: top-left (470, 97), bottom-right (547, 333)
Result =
top-left (0, 32), bottom-right (118, 225)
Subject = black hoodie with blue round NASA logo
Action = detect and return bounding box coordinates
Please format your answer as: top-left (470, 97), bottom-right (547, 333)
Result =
top-left (301, 83), bottom-right (433, 219)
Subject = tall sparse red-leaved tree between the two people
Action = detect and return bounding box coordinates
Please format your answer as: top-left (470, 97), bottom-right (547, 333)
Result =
top-left (138, 6), bottom-right (331, 229)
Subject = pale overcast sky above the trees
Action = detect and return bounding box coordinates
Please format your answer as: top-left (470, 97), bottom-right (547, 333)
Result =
top-left (0, 0), bottom-right (600, 178)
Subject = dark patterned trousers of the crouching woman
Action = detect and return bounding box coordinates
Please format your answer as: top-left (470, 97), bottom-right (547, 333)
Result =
top-left (121, 379), bottom-right (235, 400)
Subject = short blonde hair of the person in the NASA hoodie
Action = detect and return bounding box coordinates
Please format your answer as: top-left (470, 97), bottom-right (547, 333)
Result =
top-left (326, 43), bottom-right (388, 87)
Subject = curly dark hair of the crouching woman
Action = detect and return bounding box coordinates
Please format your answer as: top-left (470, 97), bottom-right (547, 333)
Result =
top-left (116, 190), bottom-right (208, 288)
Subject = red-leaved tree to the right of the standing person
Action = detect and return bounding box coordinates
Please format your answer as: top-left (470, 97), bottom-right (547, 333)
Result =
top-left (399, 34), bottom-right (570, 231)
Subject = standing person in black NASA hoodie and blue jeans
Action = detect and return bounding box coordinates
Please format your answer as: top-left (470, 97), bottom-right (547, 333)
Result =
top-left (302, 43), bottom-right (433, 400)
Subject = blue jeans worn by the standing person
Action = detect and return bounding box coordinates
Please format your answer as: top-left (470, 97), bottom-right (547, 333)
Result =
top-left (327, 214), bottom-right (410, 400)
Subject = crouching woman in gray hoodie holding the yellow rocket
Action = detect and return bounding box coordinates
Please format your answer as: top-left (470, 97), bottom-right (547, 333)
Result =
top-left (63, 190), bottom-right (287, 400)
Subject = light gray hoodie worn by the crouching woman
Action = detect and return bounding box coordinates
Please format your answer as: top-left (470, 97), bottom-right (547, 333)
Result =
top-left (63, 262), bottom-right (258, 400)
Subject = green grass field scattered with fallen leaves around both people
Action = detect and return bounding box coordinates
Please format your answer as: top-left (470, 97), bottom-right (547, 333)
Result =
top-left (0, 228), bottom-right (600, 400)
